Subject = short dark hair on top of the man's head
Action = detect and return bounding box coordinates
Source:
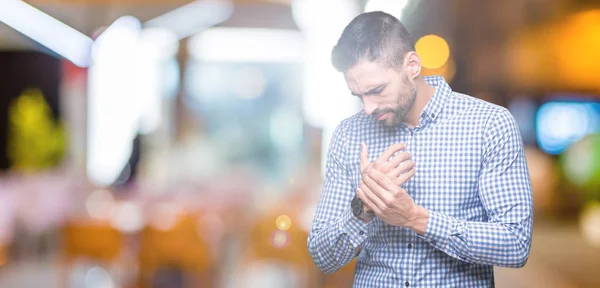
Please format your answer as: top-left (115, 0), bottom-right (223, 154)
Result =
top-left (331, 11), bottom-right (415, 72)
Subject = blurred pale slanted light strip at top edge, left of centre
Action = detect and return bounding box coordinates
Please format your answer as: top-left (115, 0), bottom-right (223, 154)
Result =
top-left (144, 0), bottom-right (233, 40)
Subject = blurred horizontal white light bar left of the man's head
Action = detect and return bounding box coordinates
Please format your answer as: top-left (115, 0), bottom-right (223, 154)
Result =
top-left (188, 28), bottom-right (304, 63)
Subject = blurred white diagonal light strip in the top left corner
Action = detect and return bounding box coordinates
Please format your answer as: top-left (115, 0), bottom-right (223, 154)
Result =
top-left (0, 0), bottom-right (93, 67)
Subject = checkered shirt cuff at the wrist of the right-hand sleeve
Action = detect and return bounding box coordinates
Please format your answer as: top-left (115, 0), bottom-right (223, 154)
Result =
top-left (417, 210), bottom-right (457, 250)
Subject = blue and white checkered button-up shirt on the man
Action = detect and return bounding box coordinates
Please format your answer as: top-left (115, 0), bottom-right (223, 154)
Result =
top-left (308, 76), bottom-right (533, 287)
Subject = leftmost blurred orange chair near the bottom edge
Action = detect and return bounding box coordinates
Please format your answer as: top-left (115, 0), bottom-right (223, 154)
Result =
top-left (59, 221), bottom-right (125, 287)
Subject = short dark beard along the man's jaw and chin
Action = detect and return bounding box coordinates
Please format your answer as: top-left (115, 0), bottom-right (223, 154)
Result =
top-left (373, 75), bottom-right (417, 128)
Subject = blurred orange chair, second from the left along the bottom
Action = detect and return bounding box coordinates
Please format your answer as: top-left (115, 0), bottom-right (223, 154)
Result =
top-left (138, 214), bottom-right (216, 287)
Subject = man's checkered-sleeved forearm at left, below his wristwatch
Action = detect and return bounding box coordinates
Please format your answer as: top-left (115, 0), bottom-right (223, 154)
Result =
top-left (308, 209), bottom-right (369, 274)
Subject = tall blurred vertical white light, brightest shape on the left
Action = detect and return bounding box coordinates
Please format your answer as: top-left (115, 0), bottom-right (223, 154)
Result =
top-left (87, 16), bottom-right (148, 186)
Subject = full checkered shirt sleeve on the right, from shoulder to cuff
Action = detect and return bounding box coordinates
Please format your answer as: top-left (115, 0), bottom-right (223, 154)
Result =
top-left (423, 109), bottom-right (533, 268)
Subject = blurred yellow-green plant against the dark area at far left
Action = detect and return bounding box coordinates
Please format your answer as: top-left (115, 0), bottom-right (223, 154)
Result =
top-left (7, 89), bottom-right (66, 172)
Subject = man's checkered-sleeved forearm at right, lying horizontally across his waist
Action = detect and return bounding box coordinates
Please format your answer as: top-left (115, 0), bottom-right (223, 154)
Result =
top-left (414, 210), bottom-right (531, 268)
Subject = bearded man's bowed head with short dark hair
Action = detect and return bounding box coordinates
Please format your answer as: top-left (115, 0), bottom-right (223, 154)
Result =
top-left (331, 12), bottom-right (421, 127)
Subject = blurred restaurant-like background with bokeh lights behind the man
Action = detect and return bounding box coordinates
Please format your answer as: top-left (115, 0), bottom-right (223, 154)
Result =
top-left (0, 0), bottom-right (600, 288)
